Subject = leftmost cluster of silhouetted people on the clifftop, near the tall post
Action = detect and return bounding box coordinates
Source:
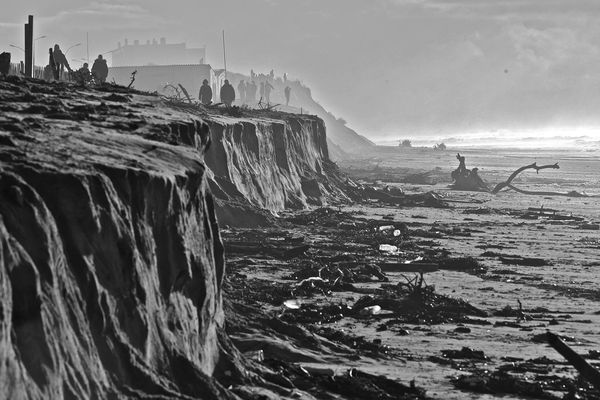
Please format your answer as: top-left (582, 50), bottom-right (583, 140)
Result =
top-left (44, 44), bottom-right (108, 83)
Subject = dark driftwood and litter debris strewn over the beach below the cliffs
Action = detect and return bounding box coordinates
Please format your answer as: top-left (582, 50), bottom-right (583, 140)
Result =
top-left (225, 192), bottom-right (597, 399)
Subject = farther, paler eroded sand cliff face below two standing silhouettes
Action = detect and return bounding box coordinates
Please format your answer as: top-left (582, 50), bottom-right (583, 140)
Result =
top-left (206, 113), bottom-right (347, 226)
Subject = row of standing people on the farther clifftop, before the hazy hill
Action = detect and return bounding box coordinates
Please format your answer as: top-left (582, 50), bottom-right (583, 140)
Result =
top-left (198, 79), bottom-right (292, 107)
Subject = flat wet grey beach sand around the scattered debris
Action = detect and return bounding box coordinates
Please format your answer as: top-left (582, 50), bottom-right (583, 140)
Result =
top-left (225, 149), bottom-right (600, 399)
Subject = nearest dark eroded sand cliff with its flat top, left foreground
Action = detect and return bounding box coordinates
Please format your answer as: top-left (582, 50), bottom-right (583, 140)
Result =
top-left (0, 76), bottom-right (232, 399)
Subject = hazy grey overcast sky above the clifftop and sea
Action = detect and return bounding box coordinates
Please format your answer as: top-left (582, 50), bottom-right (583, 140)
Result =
top-left (0, 0), bottom-right (600, 139)
